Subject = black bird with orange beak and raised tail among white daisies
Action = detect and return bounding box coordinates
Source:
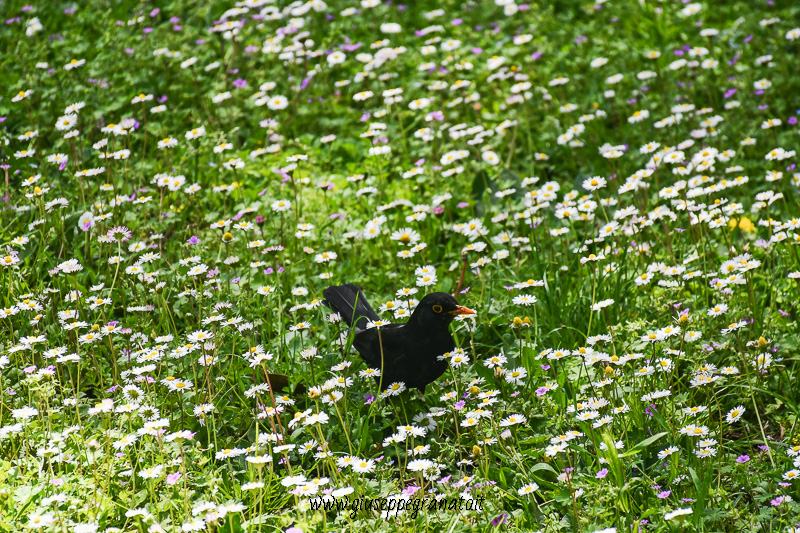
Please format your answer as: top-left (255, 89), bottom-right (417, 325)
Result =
top-left (322, 284), bottom-right (475, 392)
